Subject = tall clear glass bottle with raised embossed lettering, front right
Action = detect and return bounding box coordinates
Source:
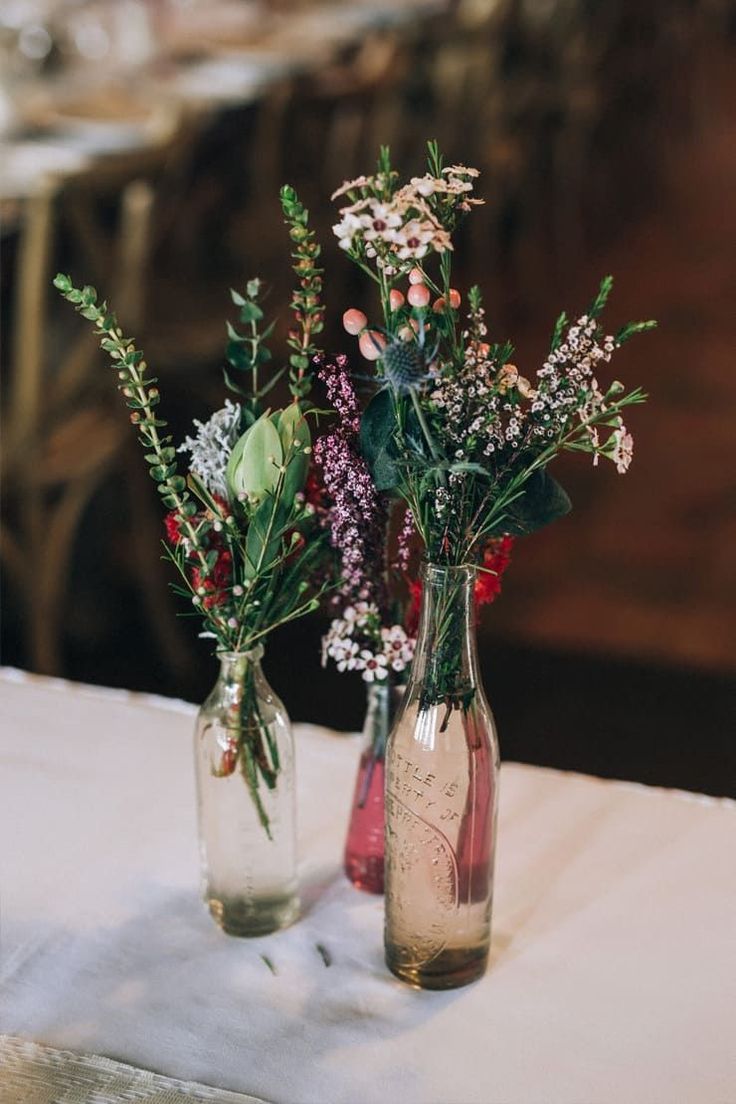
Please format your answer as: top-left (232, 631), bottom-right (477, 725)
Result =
top-left (385, 564), bottom-right (499, 989)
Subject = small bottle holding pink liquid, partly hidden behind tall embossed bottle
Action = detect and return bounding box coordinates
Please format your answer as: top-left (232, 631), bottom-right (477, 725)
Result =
top-left (344, 676), bottom-right (404, 893)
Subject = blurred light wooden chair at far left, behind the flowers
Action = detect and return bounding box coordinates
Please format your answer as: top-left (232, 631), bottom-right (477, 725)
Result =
top-left (0, 120), bottom-right (199, 675)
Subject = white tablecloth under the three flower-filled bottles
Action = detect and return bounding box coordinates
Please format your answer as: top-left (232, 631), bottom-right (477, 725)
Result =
top-left (0, 671), bottom-right (736, 1104)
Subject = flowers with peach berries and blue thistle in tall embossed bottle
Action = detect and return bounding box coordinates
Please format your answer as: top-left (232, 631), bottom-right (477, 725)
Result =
top-left (333, 142), bottom-right (655, 708)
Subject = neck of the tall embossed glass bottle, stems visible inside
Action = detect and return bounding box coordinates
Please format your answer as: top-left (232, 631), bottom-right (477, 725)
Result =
top-left (408, 563), bottom-right (479, 708)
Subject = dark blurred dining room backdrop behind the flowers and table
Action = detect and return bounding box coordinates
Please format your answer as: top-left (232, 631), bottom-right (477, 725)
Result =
top-left (0, 0), bottom-right (736, 795)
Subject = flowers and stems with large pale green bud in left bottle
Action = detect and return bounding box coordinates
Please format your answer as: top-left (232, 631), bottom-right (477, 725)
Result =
top-left (54, 188), bottom-right (329, 831)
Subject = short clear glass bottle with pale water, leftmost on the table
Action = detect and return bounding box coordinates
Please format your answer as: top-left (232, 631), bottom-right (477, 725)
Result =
top-left (194, 646), bottom-right (299, 935)
